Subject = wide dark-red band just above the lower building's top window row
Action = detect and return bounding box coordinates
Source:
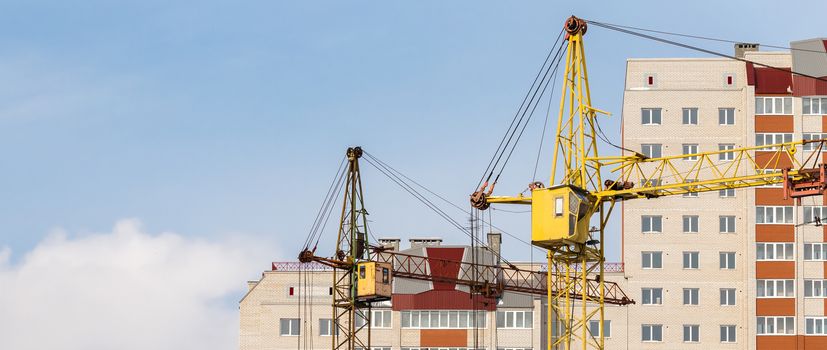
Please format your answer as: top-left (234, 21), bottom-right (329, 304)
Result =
top-left (391, 290), bottom-right (497, 311)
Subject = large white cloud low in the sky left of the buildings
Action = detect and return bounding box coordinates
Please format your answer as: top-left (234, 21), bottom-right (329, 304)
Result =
top-left (0, 220), bottom-right (277, 350)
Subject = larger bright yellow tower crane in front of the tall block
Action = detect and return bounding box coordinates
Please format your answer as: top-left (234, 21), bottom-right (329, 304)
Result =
top-left (471, 16), bottom-right (827, 350)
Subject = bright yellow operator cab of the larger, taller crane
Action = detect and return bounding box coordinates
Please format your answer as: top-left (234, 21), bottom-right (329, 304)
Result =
top-left (531, 185), bottom-right (597, 248)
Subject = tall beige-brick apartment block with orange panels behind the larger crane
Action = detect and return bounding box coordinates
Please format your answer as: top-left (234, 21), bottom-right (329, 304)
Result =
top-left (622, 39), bottom-right (827, 350)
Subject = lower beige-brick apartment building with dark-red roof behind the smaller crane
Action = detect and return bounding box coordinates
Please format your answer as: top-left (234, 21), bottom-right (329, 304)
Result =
top-left (239, 234), bottom-right (576, 350)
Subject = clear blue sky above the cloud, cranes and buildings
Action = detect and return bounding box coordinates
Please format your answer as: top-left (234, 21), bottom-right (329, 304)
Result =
top-left (0, 1), bottom-right (827, 266)
